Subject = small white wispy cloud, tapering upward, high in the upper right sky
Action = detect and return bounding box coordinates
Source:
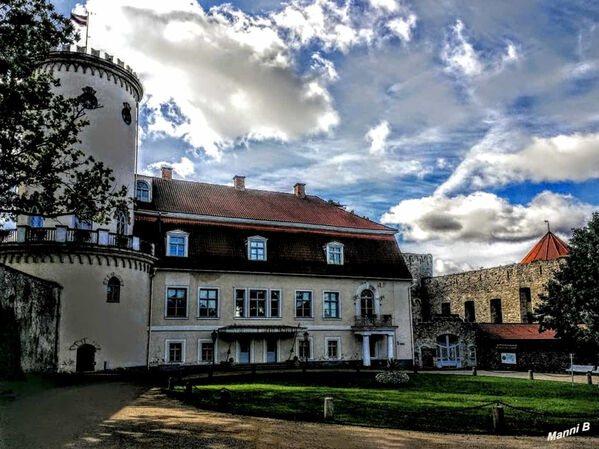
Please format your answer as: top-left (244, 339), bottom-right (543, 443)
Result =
top-left (441, 19), bottom-right (483, 77)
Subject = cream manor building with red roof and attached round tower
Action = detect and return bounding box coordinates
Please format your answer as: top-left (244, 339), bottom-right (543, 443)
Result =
top-left (0, 48), bottom-right (413, 371)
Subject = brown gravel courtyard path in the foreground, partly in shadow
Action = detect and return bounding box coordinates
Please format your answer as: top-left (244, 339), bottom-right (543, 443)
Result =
top-left (0, 383), bottom-right (599, 449)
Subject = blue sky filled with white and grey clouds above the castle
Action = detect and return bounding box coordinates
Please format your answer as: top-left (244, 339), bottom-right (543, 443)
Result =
top-left (54, 0), bottom-right (599, 274)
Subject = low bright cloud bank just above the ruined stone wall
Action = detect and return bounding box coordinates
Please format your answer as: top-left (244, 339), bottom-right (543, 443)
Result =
top-left (382, 191), bottom-right (595, 243)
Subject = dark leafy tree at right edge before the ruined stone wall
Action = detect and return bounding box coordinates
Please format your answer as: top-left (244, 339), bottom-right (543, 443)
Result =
top-left (536, 212), bottom-right (599, 356)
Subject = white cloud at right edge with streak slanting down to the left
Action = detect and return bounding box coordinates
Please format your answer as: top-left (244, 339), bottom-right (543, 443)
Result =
top-left (435, 127), bottom-right (599, 194)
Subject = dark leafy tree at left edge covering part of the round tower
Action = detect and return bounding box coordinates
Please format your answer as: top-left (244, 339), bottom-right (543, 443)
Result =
top-left (0, 0), bottom-right (128, 223)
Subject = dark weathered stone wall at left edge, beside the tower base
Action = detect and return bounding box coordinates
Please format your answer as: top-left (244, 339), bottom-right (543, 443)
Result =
top-left (0, 264), bottom-right (61, 378)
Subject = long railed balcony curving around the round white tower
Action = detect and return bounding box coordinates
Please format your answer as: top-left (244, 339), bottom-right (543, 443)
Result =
top-left (0, 226), bottom-right (154, 256)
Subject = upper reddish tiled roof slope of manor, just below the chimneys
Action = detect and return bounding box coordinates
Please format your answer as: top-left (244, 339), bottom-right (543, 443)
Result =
top-left (137, 178), bottom-right (395, 232)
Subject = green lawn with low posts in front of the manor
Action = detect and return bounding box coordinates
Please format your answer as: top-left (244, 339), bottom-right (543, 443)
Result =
top-left (177, 373), bottom-right (599, 435)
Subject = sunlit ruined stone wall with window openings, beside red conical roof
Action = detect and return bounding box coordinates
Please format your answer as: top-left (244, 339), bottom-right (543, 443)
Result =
top-left (420, 259), bottom-right (564, 323)
